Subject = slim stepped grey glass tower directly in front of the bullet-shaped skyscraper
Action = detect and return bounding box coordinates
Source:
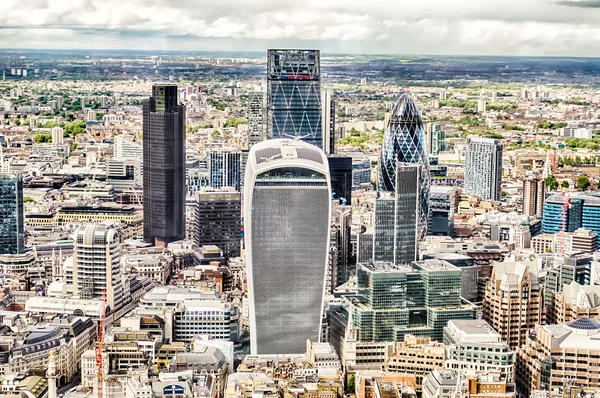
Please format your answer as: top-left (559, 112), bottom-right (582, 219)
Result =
top-left (373, 162), bottom-right (422, 264)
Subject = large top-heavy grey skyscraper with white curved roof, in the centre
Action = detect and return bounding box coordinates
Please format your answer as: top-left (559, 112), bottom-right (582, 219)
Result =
top-left (244, 139), bottom-right (331, 354)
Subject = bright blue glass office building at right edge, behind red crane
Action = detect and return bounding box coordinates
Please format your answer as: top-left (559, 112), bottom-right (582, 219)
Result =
top-left (542, 191), bottom-right (600, 234)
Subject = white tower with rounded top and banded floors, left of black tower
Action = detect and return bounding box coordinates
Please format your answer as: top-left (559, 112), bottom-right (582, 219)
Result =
top-left (73, 224), bottom-right (131, 313)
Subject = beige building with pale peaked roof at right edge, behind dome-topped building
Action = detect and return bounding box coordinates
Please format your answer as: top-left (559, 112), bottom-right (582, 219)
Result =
top-left (546, 281), bottom-right (600, 325)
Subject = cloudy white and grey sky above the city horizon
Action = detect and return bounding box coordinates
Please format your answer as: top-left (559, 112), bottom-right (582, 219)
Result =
top-left (0, 0), bottom-right (600, 57)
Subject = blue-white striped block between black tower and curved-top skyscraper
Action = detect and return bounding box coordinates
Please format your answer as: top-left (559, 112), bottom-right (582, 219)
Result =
top-left (208, 150), bottom-right (242, 191)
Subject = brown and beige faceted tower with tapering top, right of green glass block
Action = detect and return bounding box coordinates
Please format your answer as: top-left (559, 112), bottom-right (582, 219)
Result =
top-left (483, 260), bottom-right (544, 349)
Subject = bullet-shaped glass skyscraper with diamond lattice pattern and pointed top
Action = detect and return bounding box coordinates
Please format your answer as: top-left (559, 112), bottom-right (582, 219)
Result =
top-left (378, 94), bottom-right (429, 239)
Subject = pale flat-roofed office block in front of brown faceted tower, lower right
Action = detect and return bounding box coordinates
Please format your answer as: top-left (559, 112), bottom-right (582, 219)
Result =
top-left (444, 319), bottom-right (515, 382)
